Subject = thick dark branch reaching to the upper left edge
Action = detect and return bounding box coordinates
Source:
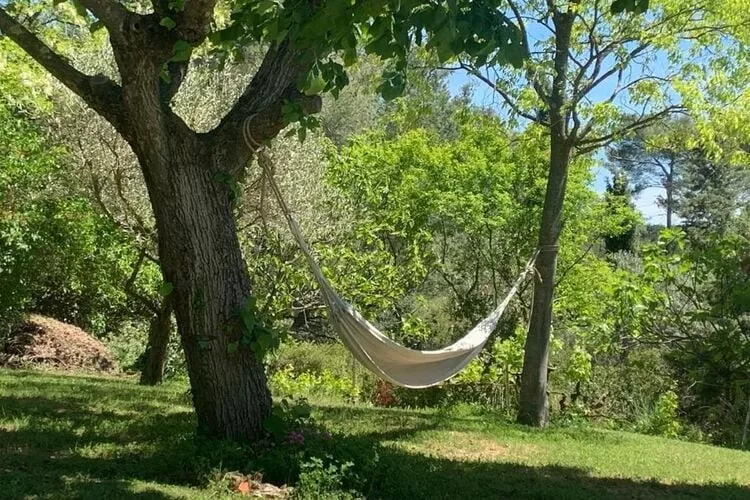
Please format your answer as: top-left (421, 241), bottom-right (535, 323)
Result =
top-left (0, 8), bottom-right (123, 132)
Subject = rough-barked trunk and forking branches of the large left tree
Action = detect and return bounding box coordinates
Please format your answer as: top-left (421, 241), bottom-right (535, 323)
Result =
top-left (0, 0), bottom-right (320, 439)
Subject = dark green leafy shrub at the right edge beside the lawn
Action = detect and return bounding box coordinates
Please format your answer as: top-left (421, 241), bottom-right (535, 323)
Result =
top-left (620, 230), bottom-right (750, 444)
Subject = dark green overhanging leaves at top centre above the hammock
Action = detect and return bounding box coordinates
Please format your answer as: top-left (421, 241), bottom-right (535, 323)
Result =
top-left (211, 0), bottom-right (528, 100)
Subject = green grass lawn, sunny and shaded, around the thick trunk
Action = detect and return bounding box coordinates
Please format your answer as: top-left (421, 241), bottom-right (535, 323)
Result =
top-left (0, 370), bottom-right (750, 499)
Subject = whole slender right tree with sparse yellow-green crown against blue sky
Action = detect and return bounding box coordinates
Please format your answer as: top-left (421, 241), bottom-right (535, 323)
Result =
top-left (459, 0), bottom-right (748, 426)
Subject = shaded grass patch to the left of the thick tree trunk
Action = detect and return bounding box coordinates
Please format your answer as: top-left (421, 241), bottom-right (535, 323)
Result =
top-left (0, 395), bottom-right (199, 499)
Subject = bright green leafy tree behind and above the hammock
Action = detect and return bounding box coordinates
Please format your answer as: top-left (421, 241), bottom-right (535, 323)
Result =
top-left (322, 113), bottom-right (560, 345)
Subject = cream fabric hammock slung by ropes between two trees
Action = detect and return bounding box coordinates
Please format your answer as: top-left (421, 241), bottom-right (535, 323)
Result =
top-left (250, 129), bottom-right (536, 389)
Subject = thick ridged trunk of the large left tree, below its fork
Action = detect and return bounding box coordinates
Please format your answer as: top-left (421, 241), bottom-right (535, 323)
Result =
top-left (141, 135), bottom-right (271, 439)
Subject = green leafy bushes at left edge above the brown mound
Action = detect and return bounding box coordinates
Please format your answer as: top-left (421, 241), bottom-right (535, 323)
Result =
top-left (0, 96), bottom-right (148, 335)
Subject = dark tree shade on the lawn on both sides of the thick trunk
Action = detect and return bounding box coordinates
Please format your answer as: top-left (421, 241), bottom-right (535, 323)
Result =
top-left (0, 386), bottom-right (750, 500)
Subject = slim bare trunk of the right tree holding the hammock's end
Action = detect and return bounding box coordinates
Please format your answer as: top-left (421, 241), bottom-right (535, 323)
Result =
top-left (517, 7), bottom-right (574, 427)
